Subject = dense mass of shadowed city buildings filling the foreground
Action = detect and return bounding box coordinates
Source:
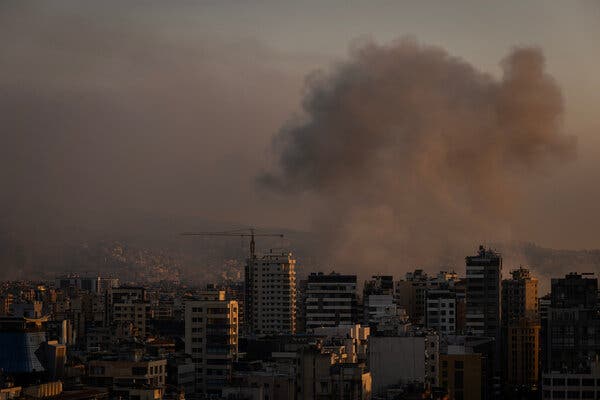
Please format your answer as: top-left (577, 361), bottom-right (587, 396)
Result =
top-left (0, 246), bottom-right (600, 400)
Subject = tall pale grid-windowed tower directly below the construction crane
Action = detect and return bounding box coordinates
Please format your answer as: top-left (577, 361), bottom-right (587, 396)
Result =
top-left (245, 250), bottom-right (296, 334)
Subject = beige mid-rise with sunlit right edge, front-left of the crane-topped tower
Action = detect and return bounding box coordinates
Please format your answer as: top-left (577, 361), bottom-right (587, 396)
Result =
top-left (185, 291), bottom-right (238, 395)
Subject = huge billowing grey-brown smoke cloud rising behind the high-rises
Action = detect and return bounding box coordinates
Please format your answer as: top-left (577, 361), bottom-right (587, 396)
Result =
top-left (259, 39), bottom-right (575, 272)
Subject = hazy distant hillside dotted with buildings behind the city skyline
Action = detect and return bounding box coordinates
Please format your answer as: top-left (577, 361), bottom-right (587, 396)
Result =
top-left (0, 216), bottom-right (600, 290)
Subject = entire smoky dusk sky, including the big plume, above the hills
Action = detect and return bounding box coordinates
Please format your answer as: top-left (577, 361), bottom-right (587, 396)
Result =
top-left (0, 1), bottom-right (600, 282)
